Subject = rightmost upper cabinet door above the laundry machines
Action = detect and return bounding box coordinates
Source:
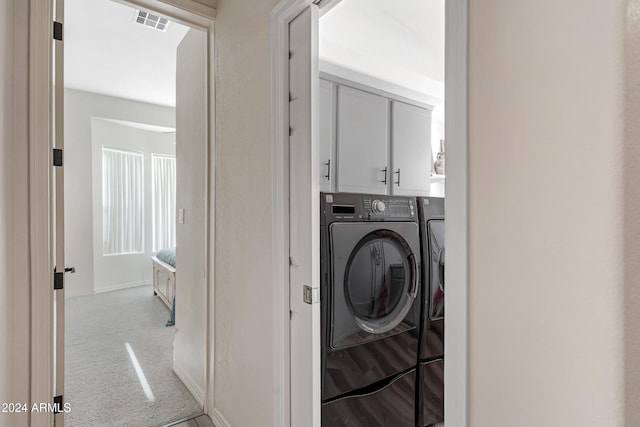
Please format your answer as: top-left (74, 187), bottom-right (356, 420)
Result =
top-left (391, 101), bottom-right (431, 196)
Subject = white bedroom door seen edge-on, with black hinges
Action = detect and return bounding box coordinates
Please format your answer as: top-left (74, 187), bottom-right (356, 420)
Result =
top-left (53, 0), bottom-right (66, 427)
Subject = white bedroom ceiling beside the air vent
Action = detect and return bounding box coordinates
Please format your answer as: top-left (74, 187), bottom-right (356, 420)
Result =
top-left (64, 0), bottom-right (188, 106)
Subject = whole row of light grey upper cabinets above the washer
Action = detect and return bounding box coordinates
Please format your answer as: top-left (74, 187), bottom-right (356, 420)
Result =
top-left (318, 78), bottom-right (433, 196)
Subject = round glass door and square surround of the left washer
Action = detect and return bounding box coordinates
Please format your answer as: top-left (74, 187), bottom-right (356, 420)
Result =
top-left (332, 224), bottom-right (419, 348)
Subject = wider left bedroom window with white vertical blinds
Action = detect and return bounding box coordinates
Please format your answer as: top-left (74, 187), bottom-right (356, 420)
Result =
top-left (102, 147), bottom-right (144, 255)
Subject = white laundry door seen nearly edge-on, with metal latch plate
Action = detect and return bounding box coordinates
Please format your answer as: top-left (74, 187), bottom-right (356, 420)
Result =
top-left (289, 5), bottom-right (320, 427)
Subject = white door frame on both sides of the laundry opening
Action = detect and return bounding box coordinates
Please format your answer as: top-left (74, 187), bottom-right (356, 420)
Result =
top-left (271, 0), bottom-right (469, 427)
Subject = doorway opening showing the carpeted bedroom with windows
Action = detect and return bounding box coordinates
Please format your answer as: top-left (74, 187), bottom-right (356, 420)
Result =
top-left (64, 0), bottom-right (209, 426)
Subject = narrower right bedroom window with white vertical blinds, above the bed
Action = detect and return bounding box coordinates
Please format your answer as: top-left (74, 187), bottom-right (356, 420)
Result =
top-left (151, 154), bottom-right (176, 252)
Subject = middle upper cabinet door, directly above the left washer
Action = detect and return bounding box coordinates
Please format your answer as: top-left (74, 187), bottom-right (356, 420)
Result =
top-left (336, 86), bottom-right (391, 194)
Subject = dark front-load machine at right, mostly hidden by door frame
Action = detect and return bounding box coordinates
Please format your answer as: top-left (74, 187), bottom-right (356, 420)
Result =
top-left (416, 197), bottom-right (445, 427)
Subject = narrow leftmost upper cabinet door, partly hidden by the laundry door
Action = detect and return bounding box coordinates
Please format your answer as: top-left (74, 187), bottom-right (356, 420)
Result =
top-left (319, 79), bottom-right (335, 191)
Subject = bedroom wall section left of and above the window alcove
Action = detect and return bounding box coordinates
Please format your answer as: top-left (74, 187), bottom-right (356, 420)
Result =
top-left (64, 89), bottom-right (175, 297)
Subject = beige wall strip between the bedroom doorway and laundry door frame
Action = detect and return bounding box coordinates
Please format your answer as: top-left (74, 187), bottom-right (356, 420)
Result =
top-left (214, 0), bottom-right (278, 426)
